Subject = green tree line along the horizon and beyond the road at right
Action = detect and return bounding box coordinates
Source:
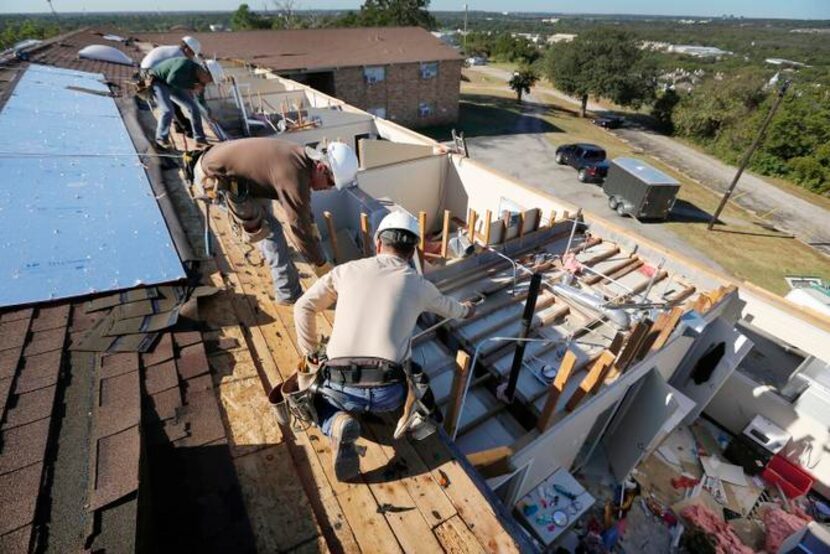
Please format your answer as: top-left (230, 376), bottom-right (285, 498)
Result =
top-left (0, 0), bottom-right (830, 194)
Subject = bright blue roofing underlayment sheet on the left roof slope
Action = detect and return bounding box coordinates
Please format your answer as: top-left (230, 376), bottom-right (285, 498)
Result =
top-left (0, 65), bottom-right (185, 306)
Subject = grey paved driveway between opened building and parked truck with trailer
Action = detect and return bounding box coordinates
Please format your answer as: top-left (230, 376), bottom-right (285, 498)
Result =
top-left (467, 96), bottom-right (723, 270)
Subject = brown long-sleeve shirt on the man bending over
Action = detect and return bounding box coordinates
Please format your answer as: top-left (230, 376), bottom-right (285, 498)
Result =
top-left (201, 137), bottom-right (326, 265)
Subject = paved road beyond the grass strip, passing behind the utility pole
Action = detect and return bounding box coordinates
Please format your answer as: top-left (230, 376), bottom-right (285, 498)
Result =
top-left (468, 66), bottom-right (830, 254)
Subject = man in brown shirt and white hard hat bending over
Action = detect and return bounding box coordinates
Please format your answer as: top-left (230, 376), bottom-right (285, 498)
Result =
top-left (193, 137), bottom-right (358, 305)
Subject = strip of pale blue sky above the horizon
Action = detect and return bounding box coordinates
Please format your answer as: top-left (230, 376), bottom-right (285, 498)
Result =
top-left (0, 0), bottom-right (830, 19)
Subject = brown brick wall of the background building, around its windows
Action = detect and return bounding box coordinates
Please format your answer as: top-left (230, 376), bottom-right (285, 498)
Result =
top-left (334, 60), bottom-right (462, 127)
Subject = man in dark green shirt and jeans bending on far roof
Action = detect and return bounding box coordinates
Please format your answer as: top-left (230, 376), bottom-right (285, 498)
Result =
top-left (150, 58), bottom-right (212, 149)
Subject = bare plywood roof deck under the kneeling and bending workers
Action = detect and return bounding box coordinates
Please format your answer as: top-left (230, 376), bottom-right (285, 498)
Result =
top-left (159, 141), bottom-right (520, 552)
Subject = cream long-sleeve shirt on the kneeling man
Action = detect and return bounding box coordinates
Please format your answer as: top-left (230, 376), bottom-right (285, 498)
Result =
top-left (294, 254), bottom-right (467, 363)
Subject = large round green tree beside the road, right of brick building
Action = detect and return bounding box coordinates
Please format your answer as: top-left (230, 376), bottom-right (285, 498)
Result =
top-left (545, 28), bottom-right (656, 117)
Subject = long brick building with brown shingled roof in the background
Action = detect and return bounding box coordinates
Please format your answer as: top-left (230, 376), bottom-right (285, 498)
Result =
top-left (140, 27), bottom-right (463, 127)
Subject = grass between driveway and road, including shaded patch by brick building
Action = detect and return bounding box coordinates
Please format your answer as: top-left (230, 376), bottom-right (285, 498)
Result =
top-left (452, 83), bottom-right (830, 294)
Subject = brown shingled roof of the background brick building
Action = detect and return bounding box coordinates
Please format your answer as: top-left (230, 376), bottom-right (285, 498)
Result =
top-left (138, 27), bottom-right (462, 71)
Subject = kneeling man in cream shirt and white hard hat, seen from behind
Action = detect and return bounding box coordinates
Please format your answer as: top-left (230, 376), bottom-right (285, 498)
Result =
top-left (294, 211), bottom-right (474, 480)
